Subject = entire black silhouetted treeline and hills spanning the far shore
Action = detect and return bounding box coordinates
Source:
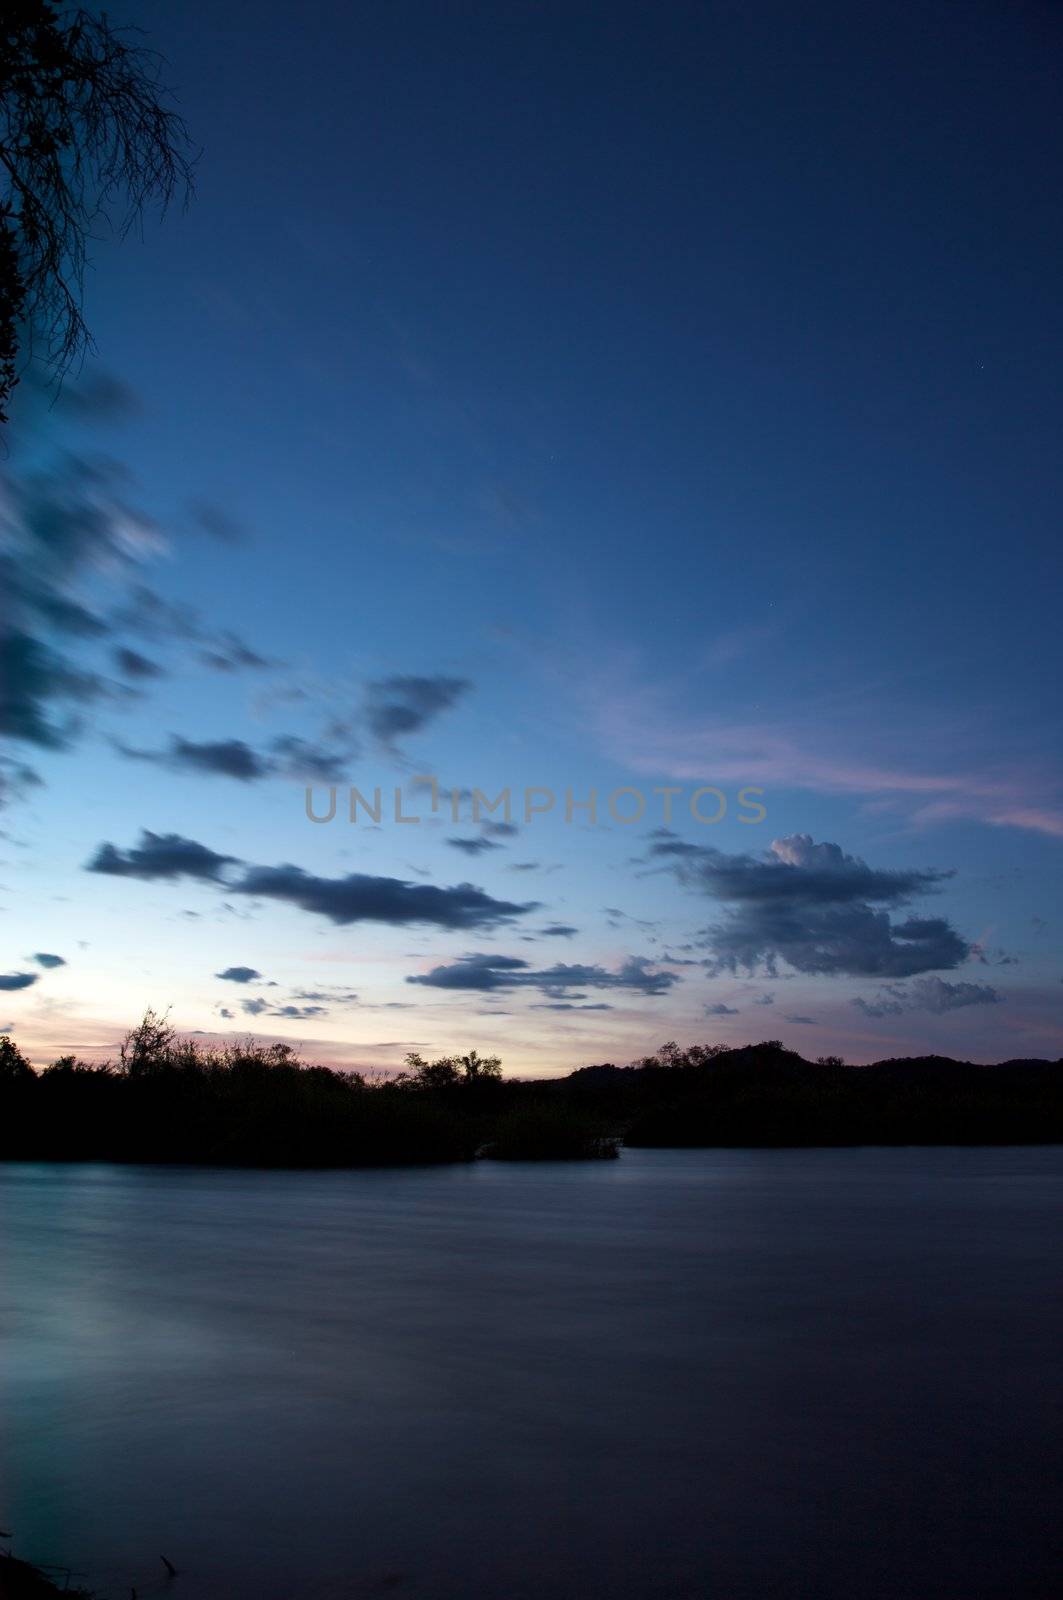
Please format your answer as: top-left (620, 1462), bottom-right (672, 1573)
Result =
top-left (0, 1013), bottom-right (1063, 1166)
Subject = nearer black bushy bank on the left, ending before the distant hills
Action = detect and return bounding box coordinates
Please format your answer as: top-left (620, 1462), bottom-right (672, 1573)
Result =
top-left (0, 1011), bottom-right (616, 1166)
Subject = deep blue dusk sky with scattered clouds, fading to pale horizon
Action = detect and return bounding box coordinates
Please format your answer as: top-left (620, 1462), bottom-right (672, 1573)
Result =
top-left (0, 0), bottom-right (1063, 1075)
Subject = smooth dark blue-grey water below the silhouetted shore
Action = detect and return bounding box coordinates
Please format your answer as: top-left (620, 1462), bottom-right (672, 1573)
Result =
top-left (0, 1149), bottom-right (1063, 1600)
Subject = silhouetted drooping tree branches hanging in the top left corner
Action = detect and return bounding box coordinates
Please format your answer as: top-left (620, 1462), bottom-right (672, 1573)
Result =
top-left (0, 0), bottom-right (192, 421)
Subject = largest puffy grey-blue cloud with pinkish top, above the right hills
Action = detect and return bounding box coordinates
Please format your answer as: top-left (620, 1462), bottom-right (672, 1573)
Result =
top-left (650, 829), bottom-right (970, 978)
